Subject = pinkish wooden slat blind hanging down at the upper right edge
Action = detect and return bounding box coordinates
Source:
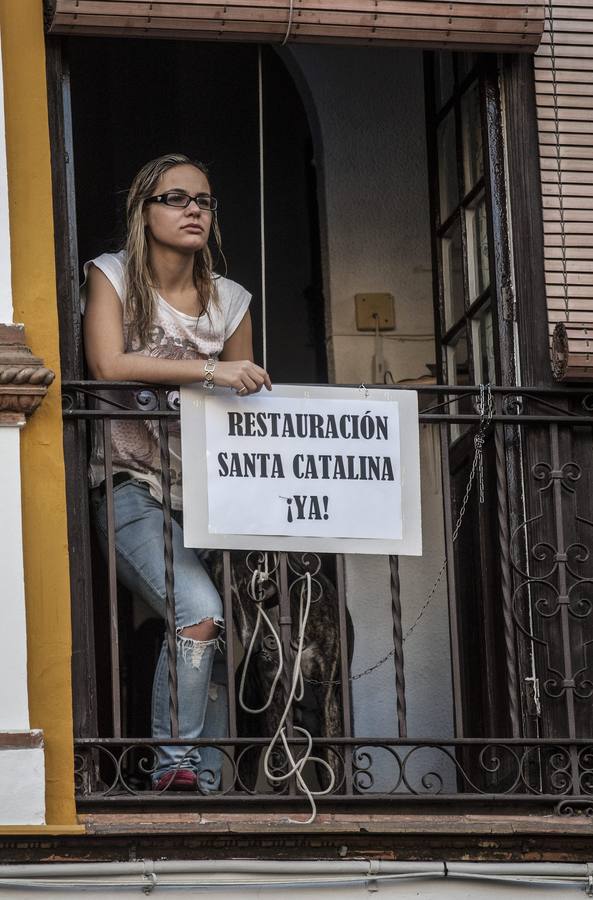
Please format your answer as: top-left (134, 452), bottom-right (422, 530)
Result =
top-left (535, 0), bottom-right (593, 380)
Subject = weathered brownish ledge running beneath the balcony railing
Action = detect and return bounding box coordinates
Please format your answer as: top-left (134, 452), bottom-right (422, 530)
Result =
top-left (0, 812), bottom-right (593, 864)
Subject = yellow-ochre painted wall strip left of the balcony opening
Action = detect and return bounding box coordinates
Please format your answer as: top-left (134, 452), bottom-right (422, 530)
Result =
top-left (0, 0), bottom-right (76, 824)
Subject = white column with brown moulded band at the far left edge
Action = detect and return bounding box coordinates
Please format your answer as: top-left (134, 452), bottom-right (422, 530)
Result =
top-left (0, 31), bottom-right (53, 825)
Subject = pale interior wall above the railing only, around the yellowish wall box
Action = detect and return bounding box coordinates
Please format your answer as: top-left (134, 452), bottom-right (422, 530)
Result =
top-left (291, 45), bottom-right (434, 383)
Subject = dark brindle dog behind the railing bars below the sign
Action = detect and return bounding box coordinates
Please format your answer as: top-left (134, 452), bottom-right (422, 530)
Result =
top-left (211, 551), bottom-right (354, 791)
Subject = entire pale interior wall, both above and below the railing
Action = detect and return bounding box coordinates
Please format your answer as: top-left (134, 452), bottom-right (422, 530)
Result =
top-left (289, 45), bottom-right (453, 789)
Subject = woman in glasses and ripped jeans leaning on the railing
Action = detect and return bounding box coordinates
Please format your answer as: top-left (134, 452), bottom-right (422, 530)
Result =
top-left (83, 154), bottom-right (271, 790)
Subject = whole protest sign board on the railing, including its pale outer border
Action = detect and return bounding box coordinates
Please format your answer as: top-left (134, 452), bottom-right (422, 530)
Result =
top-left (181, 385), bottom-right (421, 554)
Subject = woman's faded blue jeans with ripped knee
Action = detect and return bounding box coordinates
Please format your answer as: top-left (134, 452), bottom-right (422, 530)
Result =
top-left (91, 480), bottom-right (228, 791)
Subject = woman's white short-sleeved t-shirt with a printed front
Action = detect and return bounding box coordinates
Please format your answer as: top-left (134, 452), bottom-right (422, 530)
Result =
top-left (81, 250), bottom-right (251, 509)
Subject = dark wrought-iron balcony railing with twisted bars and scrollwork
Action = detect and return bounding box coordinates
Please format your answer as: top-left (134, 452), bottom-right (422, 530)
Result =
top-left (63, 381), bottom-right (593, 815)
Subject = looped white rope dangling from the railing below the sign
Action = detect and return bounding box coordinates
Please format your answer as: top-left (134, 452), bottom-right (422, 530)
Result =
top-left (239, 554), bottom-right (336, 825)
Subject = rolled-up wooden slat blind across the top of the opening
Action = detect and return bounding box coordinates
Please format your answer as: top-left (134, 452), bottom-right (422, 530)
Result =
top-left (46, 0), bottom-right (543, 51)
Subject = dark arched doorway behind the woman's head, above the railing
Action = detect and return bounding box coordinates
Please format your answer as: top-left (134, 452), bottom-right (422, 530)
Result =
top-left (65, 38), bottom-right (327, 382)
